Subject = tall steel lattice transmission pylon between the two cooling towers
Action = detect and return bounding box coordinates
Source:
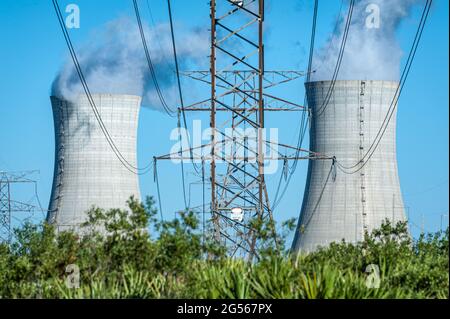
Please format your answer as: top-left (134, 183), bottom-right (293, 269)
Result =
top-left (156, 0), bottom-right (330, 260)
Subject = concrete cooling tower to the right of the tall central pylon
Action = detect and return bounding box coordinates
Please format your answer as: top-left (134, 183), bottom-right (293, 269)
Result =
top-left (292, 81), bottom-right (405, 252)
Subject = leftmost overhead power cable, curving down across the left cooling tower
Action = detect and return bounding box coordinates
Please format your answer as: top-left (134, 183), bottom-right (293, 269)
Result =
top-left (52, 0), bottom-right (151, 175)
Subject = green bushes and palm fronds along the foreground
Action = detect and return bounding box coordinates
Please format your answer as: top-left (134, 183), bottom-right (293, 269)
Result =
top-left (0, 198), bottom-right (449, 299)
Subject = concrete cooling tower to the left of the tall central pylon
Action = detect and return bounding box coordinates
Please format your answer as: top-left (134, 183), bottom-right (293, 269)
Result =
top-left (47, 94), bottom-right (141, 231)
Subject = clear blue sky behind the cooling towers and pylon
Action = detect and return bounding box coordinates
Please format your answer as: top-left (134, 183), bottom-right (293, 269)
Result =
top-left (0, 0), bottom-right (449, 240)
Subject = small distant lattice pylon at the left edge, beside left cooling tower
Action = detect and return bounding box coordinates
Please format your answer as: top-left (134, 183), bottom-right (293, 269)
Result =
top-left (0, 171), bottom-right (42, 242)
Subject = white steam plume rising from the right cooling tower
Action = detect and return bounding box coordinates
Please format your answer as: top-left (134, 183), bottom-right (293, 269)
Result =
top-left (311, 0), bottom-right (424, 81)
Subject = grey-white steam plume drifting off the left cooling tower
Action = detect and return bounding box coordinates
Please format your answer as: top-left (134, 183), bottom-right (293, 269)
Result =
top-left (52, 18), bottom-right (208, 110)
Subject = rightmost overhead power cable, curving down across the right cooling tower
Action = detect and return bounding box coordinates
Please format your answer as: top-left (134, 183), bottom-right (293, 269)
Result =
top-left (337, 0), bottom-right (433, 174)
